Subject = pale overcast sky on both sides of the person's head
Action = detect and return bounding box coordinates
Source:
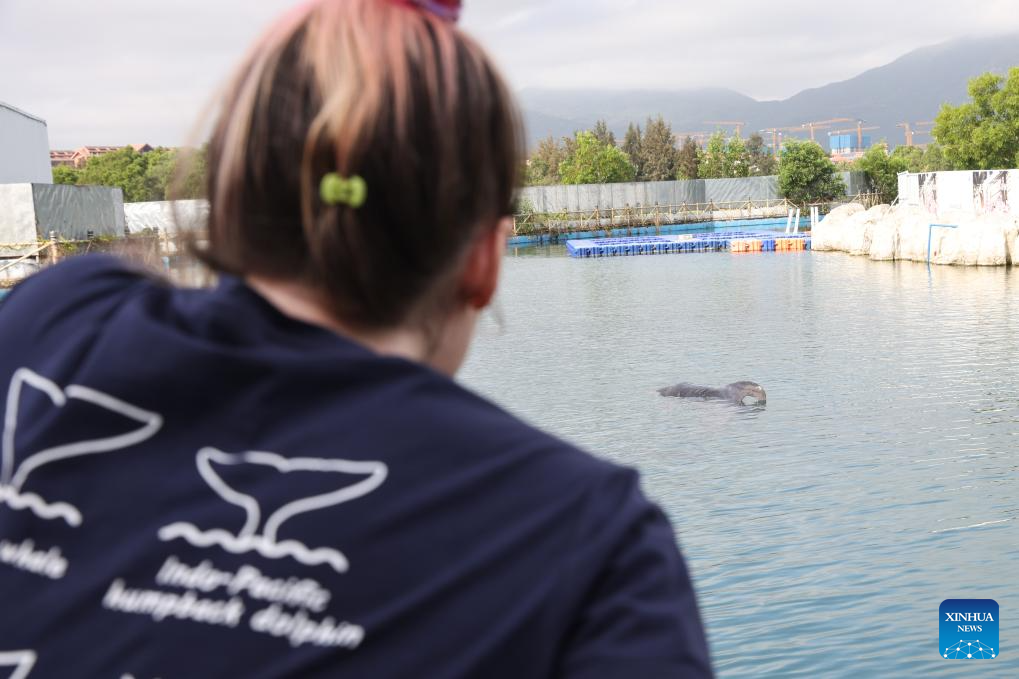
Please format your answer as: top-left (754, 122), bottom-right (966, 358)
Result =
top-left (0, 0), bottom-right (1019, 148)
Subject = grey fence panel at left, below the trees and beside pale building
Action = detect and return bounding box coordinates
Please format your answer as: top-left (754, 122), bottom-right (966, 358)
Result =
top-left (32, 184), bottom-right (125, 241)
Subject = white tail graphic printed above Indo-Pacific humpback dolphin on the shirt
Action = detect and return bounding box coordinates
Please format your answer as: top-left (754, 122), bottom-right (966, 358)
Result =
top-left (159, 448), bottom-right (388, 573)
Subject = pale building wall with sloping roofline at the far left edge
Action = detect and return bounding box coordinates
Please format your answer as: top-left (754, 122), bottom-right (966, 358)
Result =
top-left (0, 102), bottom-right (53, 184)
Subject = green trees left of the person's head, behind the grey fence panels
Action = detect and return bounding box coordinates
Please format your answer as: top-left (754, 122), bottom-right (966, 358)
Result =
top-left (53, 146), bottom-right (206, 203)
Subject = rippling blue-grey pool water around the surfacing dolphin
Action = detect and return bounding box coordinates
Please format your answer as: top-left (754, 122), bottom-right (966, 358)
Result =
top-left (462, 248), bottom-right (1019, 677)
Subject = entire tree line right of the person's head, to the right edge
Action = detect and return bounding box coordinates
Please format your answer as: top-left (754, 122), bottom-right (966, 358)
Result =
top-left (527, 67), bottom-right (1019, 201)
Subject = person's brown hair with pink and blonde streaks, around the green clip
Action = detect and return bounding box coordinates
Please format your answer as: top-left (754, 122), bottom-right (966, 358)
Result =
top-left (203, 0), bottom-right (522, 329)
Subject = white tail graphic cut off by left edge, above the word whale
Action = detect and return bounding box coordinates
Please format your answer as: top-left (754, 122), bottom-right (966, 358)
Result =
top-left (0, 368), bottom-right (163, 526)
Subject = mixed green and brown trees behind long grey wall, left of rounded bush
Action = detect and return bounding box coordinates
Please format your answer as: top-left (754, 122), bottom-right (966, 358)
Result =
top-left (527, 116), bottom-right (777, 186)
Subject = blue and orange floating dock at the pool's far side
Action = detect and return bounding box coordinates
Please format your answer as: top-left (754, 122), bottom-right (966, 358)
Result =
top-left (567, 231), bottom-right (810, 257)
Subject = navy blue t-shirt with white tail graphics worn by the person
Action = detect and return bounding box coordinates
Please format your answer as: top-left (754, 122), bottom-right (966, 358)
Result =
top-left (0, 257), bottom-right (711, 679)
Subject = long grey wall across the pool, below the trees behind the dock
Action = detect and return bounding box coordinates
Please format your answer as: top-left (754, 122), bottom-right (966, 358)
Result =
top-left (520, 172), bottom-right (866, 212)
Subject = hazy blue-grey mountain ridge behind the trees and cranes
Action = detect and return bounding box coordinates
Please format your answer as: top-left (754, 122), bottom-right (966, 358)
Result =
top-left (520, 35), bottom-right (1019, 146)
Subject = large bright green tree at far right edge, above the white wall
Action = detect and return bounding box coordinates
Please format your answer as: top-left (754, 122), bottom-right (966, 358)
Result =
top-left (933, 67), bottom-right (1019, 169)
